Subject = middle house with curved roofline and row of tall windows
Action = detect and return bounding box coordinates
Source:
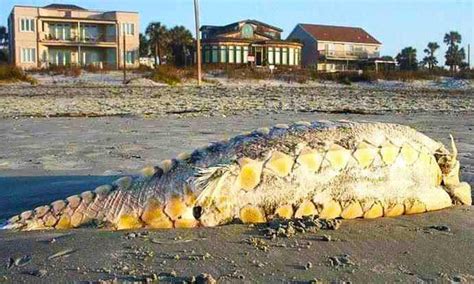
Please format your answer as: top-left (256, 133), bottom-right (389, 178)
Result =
top-left (200, 20), bottom-right (303, 67)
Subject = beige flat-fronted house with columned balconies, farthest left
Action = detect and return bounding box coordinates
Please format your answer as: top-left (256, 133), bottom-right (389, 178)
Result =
top-left (8, 4), bottom-right (139, 69)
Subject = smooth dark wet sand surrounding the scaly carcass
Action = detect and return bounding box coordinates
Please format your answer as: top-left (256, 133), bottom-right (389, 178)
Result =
top-left (0, 112), bottom-right (474, 283)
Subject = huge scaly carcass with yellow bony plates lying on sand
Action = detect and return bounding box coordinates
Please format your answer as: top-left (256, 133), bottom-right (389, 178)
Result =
top-left (2, 121), bottom-right (472, 230)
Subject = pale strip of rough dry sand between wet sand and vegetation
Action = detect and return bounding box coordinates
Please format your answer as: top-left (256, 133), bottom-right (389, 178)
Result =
top-left (0, 83), bottom-right (474, 118)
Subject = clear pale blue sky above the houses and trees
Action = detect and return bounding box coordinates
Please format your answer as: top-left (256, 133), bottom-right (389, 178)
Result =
top-left (0, 0), bottom-right (474, 66)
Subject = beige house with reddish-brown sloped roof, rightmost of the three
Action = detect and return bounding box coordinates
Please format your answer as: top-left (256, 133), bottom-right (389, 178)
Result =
top-left (287, 24), bottom-right (394, 72)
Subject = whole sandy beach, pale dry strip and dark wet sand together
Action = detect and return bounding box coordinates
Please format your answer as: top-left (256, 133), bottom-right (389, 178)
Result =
top-left (0, 82), bottom-right (474, 283)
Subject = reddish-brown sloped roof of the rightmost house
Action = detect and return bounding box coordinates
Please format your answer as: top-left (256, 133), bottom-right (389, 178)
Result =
top-left (299, 24), bottom-right (382, 44)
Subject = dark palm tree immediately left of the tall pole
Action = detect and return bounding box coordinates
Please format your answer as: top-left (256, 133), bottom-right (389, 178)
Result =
top-left (169, 26), bottom-right (193, 66)
